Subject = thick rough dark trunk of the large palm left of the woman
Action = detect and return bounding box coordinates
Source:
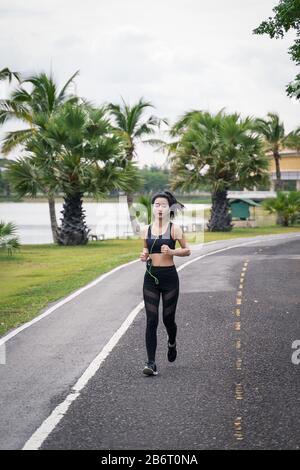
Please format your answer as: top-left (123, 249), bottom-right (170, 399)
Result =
top-left (57, 193), bottom-right (91, 245)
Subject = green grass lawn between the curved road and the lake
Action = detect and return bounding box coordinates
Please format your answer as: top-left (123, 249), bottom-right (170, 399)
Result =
top-left (0, 226), bottom-right (300, 335)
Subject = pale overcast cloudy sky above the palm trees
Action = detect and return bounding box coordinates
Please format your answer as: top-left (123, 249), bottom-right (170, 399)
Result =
top-left (0, 0), bottom-right (300, 166)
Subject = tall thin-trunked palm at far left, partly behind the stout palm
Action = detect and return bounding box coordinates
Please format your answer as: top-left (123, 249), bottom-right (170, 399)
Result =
top-left (0, 71), bottom-right (79, 242)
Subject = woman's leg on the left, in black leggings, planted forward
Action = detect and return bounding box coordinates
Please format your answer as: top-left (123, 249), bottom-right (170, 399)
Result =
top-left (143, 282), bottom-right (160, 362)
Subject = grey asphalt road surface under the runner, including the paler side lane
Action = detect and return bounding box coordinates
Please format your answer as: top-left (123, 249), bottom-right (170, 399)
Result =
top-left (0, 234), bottom-right (300, 450)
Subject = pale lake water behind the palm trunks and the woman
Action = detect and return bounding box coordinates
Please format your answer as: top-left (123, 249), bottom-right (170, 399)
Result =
top-left (0, 201), bottom-right (210, 244)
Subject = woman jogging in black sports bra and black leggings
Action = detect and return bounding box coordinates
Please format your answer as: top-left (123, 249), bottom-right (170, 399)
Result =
top-left (140, 191), bottom-right (191, 375)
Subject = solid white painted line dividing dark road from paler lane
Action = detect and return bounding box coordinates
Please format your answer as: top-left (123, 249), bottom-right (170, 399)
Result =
top-left (22, 235), bottom-right (300, 450)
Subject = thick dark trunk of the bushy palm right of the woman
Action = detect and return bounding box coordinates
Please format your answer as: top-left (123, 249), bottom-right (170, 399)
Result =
top-left (207, 189), bottom-right (233, 232)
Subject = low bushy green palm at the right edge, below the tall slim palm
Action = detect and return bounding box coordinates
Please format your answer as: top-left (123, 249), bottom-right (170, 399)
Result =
top-left (262, 191), bottom-right (300, 227)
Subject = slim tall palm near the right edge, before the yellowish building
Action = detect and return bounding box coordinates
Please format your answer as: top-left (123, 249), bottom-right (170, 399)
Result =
top-left (254, 113), bottom-right (300, 191)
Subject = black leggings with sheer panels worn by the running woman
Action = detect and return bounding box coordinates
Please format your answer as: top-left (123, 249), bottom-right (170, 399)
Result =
top-left (143, 265), bottom-right (179, 362)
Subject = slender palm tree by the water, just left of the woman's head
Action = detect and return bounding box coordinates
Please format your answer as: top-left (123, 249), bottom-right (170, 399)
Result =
top-left (107, 98), bottom-right (168, 234)
